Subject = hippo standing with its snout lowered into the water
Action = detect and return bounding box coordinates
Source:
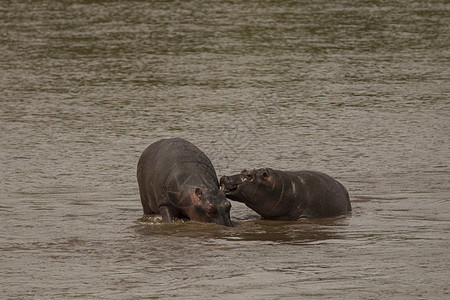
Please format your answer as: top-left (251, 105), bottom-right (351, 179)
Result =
top-left (137, 138), bottom-right (232, 226)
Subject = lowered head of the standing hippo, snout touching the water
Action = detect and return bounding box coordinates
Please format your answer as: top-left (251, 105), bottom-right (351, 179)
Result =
top-left (187, 187), bottom-right (233, 226)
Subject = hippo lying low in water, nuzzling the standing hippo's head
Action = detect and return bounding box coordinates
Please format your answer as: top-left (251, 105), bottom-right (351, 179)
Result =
top-left (220, 168), bottom-right (352, 220)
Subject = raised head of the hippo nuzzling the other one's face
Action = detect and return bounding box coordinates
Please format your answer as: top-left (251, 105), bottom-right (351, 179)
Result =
top-left (220, 168), bottom-right (284, 218)
